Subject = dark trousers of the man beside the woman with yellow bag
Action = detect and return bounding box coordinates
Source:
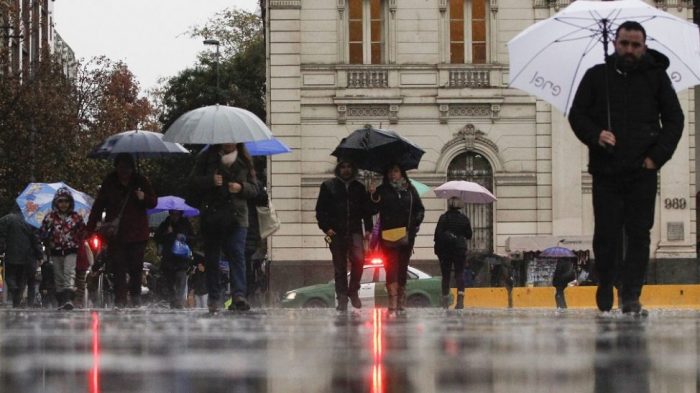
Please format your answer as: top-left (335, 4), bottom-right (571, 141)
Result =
top-left (330, 233), bottom-right (365, 299)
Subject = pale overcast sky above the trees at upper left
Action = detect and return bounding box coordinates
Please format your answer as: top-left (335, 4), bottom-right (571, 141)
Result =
top-left (53, 0), bottom-right (258, 92)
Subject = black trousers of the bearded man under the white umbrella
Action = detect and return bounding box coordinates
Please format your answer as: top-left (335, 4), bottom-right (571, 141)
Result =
top-left (593, 168), bottom-right (657, 303)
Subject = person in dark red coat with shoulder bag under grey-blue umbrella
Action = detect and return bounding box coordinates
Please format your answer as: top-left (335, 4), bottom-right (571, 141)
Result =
top-left (87, 153), bottom-right (158, 308)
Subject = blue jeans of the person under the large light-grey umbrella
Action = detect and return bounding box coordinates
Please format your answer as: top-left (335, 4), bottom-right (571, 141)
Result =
top-left (204, 227), bottom-right (248, 304)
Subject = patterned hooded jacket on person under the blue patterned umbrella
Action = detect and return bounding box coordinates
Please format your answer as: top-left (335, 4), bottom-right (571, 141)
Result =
top-left (39, 187), bottom-right (85, 255)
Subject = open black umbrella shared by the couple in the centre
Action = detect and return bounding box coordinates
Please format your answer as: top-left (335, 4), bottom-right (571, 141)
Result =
top-left (331, 125), bottom-right (425, 173)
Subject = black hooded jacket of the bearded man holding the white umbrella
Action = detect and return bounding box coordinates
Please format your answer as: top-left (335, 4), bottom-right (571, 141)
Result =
top-left (569, 49), bottom-right (683, 175)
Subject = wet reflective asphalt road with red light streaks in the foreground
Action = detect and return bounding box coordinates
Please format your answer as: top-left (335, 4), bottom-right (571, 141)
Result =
top-left (0, 309), bottom-right (700, 393)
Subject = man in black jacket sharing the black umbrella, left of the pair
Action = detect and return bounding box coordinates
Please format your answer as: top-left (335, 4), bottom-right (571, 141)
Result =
top-left (316, 158), bottom-right (372, 311)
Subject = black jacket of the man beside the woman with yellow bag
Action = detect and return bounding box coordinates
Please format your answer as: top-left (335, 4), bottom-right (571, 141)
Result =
top-left (316, 177), bottom-right (372, 235)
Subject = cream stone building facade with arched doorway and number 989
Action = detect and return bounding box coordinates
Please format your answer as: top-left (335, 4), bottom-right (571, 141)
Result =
top-left (266, 0), bottom-right (696, 288)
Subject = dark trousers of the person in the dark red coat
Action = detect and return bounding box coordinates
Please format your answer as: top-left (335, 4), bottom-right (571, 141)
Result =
top-left (108, 242), bottom-right (146, 307)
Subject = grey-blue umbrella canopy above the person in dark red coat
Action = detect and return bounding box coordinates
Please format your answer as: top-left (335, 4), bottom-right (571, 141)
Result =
top-left (88, 130), bottom-right (190, 159)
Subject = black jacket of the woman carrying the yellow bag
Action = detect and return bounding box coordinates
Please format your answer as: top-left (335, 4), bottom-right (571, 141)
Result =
top-left (372, 183), bottom-right (425, 242)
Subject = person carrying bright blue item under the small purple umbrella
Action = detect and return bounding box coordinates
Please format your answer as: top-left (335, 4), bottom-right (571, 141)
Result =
top-left (153, 210), bottom-right (194, 308)
